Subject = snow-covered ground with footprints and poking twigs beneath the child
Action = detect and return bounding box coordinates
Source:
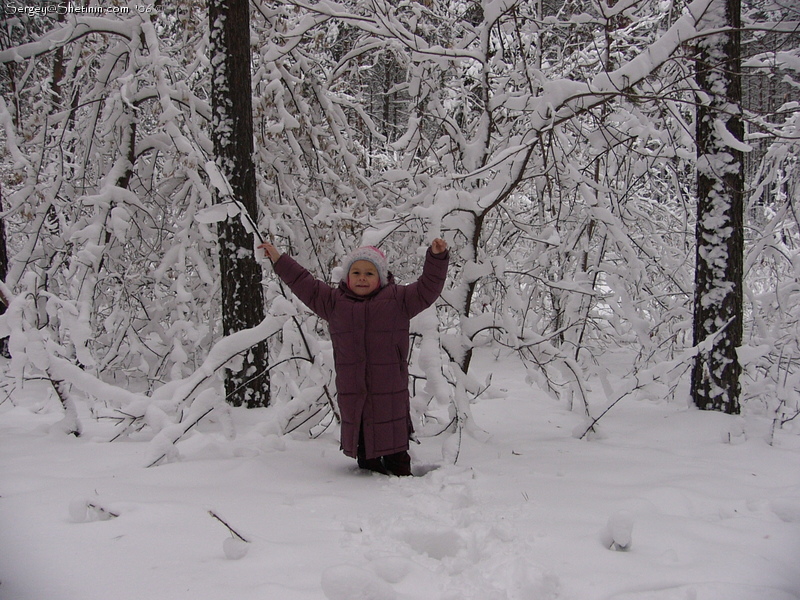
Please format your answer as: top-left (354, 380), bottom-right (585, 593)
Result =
top-left (0, 357), bottom-right (800, 600)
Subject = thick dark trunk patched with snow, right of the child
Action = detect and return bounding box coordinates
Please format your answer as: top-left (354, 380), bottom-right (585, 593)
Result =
top-left (691, 0), bottom-right (744, 414)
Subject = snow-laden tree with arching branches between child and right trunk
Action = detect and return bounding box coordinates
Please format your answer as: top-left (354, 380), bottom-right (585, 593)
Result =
top-left (266, 1), bottom-right (796, 432)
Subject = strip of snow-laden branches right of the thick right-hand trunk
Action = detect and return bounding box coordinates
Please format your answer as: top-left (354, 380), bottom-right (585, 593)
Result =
top-left (741, 2), bottom-right (800, 427)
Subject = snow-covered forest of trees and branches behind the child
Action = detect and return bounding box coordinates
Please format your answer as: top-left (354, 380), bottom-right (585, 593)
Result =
top-left (0, 0), bottom-right (800, 464)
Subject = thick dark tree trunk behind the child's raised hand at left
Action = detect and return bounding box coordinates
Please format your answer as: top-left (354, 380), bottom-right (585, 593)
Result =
top-left (208, 0), bottom-right (269, 408)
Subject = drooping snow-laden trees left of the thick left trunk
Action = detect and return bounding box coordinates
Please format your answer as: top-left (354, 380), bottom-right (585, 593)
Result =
top-left (0, 3), bottom-right (231, 436)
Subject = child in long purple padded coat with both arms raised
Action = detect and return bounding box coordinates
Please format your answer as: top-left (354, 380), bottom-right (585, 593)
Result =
top-left (259, 238), bottom-right (449, 475)
